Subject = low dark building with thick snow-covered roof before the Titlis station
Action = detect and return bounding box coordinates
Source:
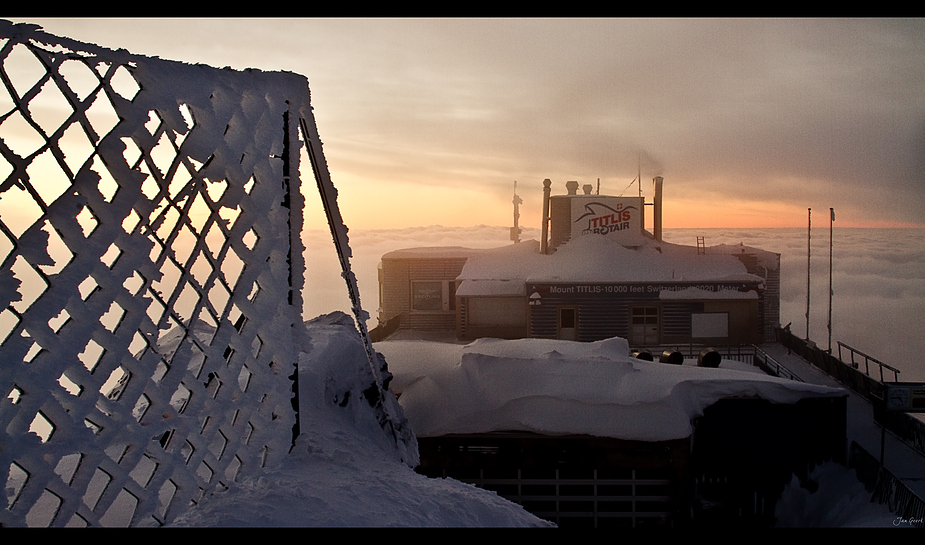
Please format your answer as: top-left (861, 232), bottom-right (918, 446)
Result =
top-left (376, 338), bottom-right (846, 527)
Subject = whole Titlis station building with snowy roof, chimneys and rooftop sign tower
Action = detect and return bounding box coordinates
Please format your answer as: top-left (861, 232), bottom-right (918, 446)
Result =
top-left (379, 177), bottom-right (780, 347)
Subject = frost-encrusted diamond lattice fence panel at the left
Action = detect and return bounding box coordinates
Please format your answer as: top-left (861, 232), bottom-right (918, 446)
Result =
top-left (0, 21), bottom-right (318, 526)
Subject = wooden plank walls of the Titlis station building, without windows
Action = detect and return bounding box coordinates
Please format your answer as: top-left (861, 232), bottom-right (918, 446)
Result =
top-left (379, 249), bottom-right (780, 344)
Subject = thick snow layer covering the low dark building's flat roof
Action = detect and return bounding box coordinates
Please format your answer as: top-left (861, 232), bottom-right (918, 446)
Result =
top-left (376, 338), bottom-right (843, 441)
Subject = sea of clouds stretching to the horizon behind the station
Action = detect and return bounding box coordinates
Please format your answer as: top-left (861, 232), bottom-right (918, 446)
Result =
top-left (302, 225), bottom-right (925, 381)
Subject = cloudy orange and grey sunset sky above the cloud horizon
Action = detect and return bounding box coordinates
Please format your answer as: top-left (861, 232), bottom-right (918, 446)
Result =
top-left (7, 18), bottom-right (925, 229)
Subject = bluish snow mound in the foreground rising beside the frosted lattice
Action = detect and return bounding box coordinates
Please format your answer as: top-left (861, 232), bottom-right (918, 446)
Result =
top-left (174, 312), bottom-right (551, 527)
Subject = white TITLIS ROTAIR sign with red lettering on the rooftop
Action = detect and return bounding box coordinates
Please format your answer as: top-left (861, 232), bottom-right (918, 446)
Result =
top-left (571, 195), bottom-right (644, 242)
